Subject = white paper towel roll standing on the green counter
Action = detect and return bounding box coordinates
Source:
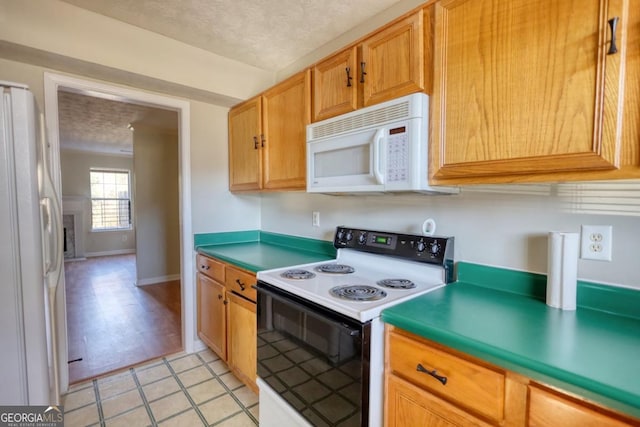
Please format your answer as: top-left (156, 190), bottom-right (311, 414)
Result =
top-left (547, 231), bottom-right (580, 310)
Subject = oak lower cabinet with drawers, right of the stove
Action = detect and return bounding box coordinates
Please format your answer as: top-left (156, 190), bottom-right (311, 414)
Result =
top-left (385, 326), bottom-right (640, 427)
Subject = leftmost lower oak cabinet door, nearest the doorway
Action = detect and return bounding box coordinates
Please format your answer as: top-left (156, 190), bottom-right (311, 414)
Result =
top-left (198, 273), bottom-right (227, 360)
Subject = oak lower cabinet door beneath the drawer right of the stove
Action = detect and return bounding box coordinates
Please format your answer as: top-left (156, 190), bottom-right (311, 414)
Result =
top-left (385, 375), bottom-right (489, 427)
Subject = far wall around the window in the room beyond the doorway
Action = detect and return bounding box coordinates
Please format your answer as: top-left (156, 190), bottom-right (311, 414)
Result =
top-left (60, 150), bottom-right (136, 257)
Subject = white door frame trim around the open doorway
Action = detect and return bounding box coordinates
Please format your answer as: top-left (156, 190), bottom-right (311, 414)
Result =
top-left (44, 72), bottom-right (196, 393)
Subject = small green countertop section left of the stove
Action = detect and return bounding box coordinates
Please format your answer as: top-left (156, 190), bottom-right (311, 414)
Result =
top-left (194, 230), bottom-right (336, 272)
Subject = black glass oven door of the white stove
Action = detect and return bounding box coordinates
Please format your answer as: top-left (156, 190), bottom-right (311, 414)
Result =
top-left (256, 281), bottom-right (371, 426)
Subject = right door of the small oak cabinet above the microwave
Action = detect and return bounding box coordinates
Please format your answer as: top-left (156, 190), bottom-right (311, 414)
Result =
top-left (356, 10), bottom-right (425, 107)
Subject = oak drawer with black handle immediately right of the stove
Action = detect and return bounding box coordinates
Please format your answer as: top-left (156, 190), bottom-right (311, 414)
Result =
top-left (389, 332), bottom-right (505, 422)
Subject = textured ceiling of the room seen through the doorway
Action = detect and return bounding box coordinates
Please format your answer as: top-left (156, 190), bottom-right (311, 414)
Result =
top-left (58, 91), bottom-right (178, 155)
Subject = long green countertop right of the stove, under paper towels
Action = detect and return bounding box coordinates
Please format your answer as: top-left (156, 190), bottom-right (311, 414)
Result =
top-left (382, 263), bottom-right (640, 417)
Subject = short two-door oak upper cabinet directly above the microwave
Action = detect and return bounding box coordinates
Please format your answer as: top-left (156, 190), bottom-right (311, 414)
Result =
top-left (313, 10), bottom-right (430, 121)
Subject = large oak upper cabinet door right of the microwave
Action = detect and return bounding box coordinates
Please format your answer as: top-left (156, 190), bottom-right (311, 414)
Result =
top-left (430, 0), bottom-right (627, 183)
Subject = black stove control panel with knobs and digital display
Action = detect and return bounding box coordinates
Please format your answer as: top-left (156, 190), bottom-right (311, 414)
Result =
top-left (333, 226), bottom-right (454, 274)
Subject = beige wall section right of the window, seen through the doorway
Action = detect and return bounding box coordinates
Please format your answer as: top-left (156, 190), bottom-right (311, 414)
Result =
top-left (133, 123), bottom-right (180, 284)
